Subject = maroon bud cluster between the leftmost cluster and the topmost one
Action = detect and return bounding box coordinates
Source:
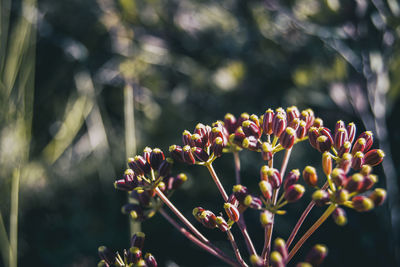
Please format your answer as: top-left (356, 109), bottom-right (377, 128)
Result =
top-left (169, 121), bottom-right (228, 165)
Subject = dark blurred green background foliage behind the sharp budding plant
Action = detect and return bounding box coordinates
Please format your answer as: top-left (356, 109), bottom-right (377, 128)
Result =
top-left (0, 0), bottom-right (400, 266)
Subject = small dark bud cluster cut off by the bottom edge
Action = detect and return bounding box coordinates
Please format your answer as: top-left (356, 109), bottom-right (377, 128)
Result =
top-left (97, 232), bottom-right (157, 267)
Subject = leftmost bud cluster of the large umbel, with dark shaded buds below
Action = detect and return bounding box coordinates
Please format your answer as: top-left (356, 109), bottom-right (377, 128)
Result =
top-left (114, 147), bottom-right (187, 221)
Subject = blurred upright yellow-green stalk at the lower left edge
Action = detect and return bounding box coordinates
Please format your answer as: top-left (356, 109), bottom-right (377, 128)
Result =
top-left (10, 168), bottom-right (20, 267)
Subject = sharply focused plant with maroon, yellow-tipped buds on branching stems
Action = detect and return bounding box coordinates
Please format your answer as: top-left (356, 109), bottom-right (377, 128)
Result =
top-left (99, 106), bottom-right (386, 267)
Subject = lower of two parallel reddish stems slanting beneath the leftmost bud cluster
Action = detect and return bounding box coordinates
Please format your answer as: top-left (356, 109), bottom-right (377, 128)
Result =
top-left (159, 208), bottom-right (239, 266)
